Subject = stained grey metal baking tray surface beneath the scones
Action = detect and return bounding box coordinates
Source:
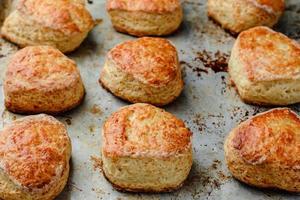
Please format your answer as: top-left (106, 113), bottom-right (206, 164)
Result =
top-left (0, 0), bottom-right (300, 200)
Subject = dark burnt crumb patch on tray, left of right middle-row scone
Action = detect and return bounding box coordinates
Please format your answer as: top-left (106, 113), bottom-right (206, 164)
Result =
top-left (195, 50), bottom-right (229, 73)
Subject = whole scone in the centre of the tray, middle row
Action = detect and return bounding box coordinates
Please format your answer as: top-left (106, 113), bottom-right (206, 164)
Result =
top-left (100, 37), bottom-right (183, 106)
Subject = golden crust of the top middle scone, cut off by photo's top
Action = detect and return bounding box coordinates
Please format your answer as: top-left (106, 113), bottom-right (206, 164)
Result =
top-left (106, 0), bottom-right (181, 14)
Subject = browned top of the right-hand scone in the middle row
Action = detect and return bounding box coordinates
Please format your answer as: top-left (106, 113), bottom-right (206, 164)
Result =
top-left (236, 27), bottom-right (300, 81)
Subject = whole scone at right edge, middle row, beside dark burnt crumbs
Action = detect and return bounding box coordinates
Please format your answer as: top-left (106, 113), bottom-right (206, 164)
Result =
top-left (229, 27), bottom-right (300, 106)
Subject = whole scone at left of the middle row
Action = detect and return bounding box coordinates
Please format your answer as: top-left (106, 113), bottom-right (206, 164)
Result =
top-left (4, 46), bottom-right (84, 114)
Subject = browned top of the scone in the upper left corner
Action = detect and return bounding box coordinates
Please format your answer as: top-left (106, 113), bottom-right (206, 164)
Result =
top-left (17, 0), bottom-right (93, 35)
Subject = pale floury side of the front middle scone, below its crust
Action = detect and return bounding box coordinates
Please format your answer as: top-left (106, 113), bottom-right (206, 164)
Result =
top-left (102, 149), bottom-right (192, 193)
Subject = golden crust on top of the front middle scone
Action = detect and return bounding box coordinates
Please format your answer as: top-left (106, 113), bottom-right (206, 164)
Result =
top-left (102, 104), bottom-right (191, 157)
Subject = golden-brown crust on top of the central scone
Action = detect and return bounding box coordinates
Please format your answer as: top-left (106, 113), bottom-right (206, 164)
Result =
top-left (107, 37), bottom-right (179, 87)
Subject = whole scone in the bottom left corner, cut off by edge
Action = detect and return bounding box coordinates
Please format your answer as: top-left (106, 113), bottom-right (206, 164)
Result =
top-left (0, 114), bottom-right (71, 200)
